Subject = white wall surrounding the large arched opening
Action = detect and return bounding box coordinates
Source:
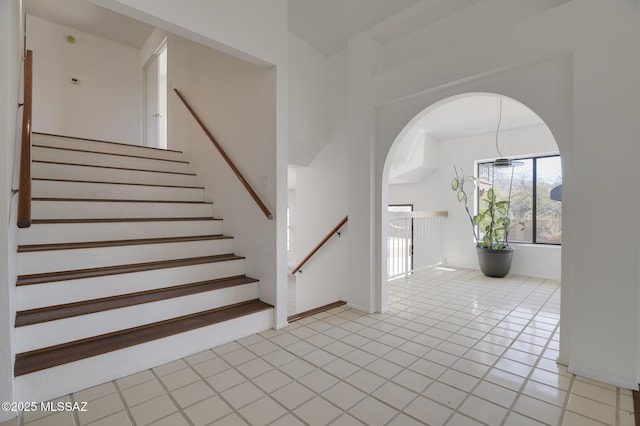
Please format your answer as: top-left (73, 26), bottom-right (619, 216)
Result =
top-left (348, 0), bottom-right (640, 388)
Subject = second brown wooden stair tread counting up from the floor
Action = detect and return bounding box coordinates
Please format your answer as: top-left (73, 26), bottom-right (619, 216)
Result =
top-left (15, 275), bottom-right (258, 327)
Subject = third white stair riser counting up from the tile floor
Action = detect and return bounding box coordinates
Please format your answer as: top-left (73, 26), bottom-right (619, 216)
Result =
top-left (16, 259), bottom-right (245, 311)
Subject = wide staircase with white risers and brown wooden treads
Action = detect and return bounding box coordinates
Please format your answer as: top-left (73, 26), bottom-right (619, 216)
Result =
top-left (14, 134), bottom-right (273, 401)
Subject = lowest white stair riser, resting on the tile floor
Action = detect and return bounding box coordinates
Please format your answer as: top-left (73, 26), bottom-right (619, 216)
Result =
top-left (14, 310), bottom-right (273, 401)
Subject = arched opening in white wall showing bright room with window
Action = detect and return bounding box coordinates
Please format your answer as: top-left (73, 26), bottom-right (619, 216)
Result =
top-left (381, 93), bottom-right (562, 310)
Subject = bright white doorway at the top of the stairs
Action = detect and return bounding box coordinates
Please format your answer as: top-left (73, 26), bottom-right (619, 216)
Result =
top-left (144, 39), bottom-right (167, 149)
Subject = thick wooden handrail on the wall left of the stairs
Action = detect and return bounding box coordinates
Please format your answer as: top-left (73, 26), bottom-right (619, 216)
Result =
top-left (18, 50), bottom-right (33, 228)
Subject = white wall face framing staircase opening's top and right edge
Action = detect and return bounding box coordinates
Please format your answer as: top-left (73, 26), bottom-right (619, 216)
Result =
top-left (89, 0), bottom-right (288, 327)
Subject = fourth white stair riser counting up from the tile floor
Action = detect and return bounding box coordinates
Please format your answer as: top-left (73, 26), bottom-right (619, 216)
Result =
top-left (18, 238), bottom-right (233, 275)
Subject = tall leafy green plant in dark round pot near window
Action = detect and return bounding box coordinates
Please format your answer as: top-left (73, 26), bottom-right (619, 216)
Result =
top-left (451, 166), bottom-right (524, 278)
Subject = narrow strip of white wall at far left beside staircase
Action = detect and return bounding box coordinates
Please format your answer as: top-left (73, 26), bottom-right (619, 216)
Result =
top-left (0, 0), bottom-right (22, 422)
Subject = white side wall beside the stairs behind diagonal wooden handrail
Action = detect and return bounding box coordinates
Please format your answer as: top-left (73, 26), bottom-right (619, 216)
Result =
top-left (168, 34), bottom-right (276, 320)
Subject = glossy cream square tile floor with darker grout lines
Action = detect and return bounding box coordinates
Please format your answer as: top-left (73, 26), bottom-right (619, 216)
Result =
top-left (5, 269), bottom-right (634, 426)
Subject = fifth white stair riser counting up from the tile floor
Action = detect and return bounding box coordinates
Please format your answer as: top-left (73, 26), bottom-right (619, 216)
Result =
top-left (18, 220), bottom-right (222, 245)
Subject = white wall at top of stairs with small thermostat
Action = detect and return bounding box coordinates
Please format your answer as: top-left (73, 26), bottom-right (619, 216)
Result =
top-left (27, 15), bottom-right (142, 145)
